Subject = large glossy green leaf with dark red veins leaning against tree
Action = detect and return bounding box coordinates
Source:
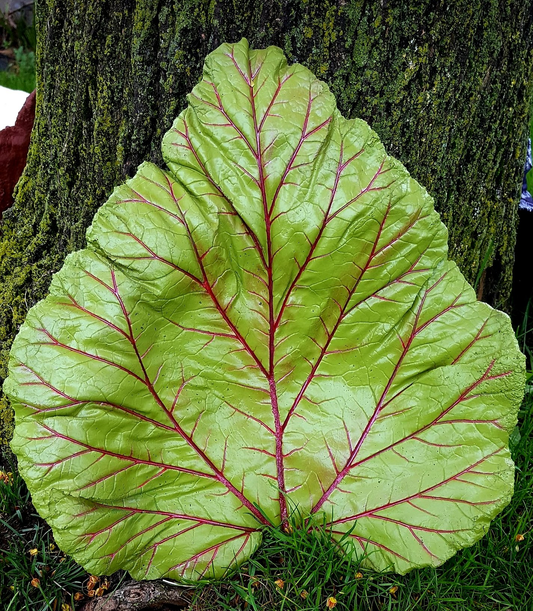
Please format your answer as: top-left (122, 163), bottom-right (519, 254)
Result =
top-left (5, 41), bottom-right (524, 579)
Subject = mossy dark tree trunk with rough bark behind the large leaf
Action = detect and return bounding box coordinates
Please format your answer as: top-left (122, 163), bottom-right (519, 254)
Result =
top-left (0, 0), bottom-right (533, 439)
